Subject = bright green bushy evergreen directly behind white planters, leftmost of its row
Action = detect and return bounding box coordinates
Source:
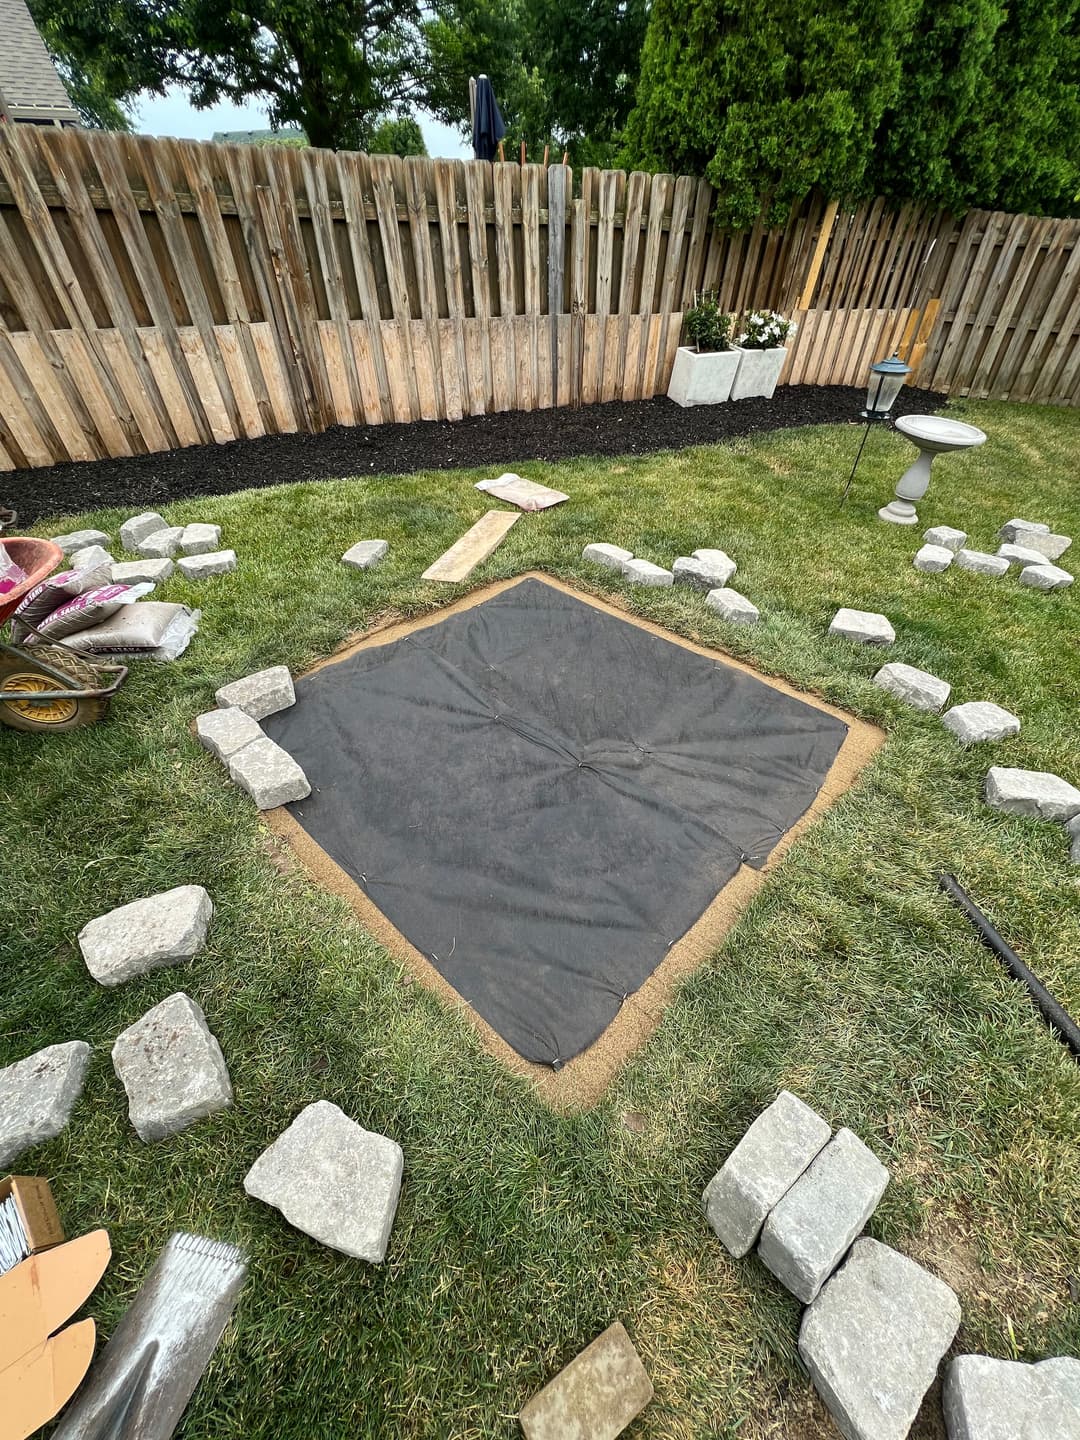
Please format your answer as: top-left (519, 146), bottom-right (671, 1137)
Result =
top-left (628, 0), bottom-right (920, 225)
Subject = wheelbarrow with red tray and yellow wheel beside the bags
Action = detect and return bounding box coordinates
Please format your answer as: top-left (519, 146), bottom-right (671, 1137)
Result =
top-left (0, 536), bottom-right (128, 734)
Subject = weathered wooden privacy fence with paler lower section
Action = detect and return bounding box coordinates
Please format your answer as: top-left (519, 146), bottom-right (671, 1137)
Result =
top-left (0, 127), bottom-right (1080, 468)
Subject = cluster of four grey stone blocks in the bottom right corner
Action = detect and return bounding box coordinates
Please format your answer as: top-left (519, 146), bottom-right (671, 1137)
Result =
top-left (703, 1090), bottom-right (1080, 1440)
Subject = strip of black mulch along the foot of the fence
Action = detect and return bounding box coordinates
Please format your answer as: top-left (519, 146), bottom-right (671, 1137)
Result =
top-left (0, 384), bottom-right (946, 527)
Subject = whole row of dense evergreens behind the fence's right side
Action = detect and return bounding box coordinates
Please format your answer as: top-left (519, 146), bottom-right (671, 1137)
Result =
top-left (624, 0), bottom-right (1080, 225)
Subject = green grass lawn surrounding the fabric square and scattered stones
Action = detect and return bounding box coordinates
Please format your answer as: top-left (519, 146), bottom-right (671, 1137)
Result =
top-left (0, 402), bottom-right (1080, 1440)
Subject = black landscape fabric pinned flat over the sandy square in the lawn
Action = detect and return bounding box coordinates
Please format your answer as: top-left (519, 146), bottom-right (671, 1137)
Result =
top-left (264, 579), bottom-right (847, 1066)
